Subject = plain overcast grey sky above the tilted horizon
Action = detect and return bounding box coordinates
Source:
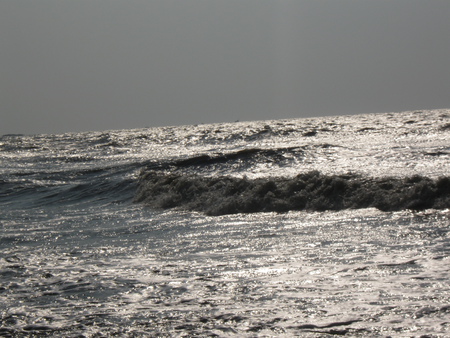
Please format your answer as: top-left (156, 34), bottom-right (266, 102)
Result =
top-left (0, 0), bottom-right (450, 135)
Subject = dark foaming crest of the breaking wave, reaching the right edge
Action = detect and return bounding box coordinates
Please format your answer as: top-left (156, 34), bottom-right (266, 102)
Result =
top-left (134, 170), bottom-right (450, 215)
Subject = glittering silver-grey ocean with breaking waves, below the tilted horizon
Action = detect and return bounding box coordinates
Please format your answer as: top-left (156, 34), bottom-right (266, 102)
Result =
top-left (0, 110), bottom-right (450, 337)
